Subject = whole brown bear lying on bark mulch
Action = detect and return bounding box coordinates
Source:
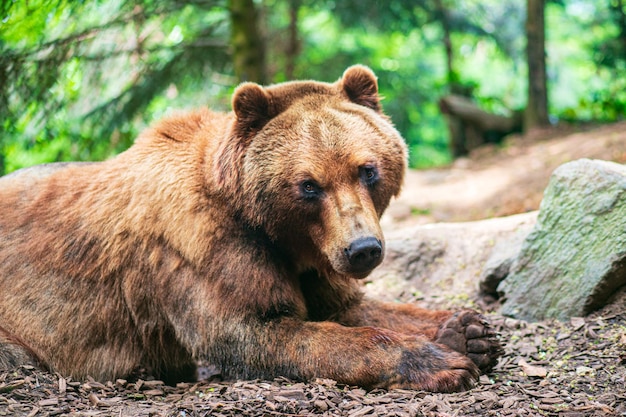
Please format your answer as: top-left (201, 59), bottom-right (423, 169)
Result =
top-left (0, 66), bottom-right (501, 391)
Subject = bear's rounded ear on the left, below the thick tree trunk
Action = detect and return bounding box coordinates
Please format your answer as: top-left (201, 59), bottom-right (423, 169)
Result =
top-left (233, 83), bottom-right (271, 136)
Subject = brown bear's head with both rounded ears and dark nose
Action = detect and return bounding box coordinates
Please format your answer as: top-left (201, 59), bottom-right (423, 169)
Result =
top-left (216, 65), bottom-right (407, 278)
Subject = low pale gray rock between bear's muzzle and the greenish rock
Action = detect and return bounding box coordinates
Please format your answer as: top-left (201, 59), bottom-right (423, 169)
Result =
top-left (365, 212), bottom-right (537, 308)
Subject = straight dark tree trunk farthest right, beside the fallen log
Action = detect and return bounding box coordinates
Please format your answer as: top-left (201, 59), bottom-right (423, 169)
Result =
top-left (524, 0), bottom-right (550, 131)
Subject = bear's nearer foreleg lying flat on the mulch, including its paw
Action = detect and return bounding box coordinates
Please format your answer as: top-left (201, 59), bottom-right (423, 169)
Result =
top-left (220, 317), bottom-right (479, 392)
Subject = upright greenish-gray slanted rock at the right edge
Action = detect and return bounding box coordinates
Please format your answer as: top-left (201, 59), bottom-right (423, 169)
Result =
top-left (498, 159), bottom-right (626, 320)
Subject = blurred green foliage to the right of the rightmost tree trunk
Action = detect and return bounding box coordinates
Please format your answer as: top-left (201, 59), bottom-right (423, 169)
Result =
top-left (548, 0), bottom-right (626, 121)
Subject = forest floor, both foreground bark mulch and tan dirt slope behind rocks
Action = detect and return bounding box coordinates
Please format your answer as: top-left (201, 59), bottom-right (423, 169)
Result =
top-left (0, 119), bottom-right (626, 417)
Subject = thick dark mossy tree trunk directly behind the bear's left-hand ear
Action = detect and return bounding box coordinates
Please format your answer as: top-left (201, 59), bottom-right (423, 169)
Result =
top-left (229, 0), bottom-right (267, 84)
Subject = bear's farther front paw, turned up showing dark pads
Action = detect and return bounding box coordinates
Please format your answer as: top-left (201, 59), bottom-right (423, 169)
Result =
top-left (435, 310), bottom-right (503, 373)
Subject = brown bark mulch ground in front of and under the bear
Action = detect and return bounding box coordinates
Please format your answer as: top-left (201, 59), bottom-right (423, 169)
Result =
top-left (0, 292), bottom-right (626, 417)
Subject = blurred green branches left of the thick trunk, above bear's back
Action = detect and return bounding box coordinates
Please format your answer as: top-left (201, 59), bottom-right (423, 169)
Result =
top-left (0, 0), bottom-right (232, 170)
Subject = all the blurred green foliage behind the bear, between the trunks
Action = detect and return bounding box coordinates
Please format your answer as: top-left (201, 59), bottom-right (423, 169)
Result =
top-left (0, 0), bottom-right (626, 173)
